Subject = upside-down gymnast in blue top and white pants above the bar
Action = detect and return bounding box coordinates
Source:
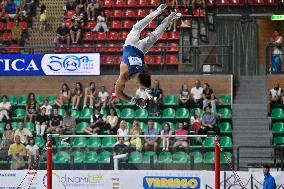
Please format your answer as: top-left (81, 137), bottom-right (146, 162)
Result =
top-left (115, 4), bottom-right (181, 106)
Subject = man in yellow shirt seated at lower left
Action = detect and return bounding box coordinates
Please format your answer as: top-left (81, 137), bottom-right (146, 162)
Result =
top-left (8, 135), bottom-right (27, 170)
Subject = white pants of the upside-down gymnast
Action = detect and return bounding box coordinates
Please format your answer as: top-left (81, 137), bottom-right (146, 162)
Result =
top-left (125, 6), bottom-right (176, 54)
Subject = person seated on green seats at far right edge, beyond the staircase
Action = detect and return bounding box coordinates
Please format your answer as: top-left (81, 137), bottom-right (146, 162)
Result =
top-left (268, 82), bottom-right (284, 115)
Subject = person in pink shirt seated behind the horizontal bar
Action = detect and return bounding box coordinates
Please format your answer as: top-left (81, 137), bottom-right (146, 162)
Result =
top-left (173, 123), bottom-right (188, 152)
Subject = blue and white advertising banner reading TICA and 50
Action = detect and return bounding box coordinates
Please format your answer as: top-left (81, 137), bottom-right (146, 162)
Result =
top-left (0, 53), bottom-right (100, 76)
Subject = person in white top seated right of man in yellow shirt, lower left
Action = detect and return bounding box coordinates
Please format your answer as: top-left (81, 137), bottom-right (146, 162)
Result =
top-left (26, 137), bottom-right (39, 170)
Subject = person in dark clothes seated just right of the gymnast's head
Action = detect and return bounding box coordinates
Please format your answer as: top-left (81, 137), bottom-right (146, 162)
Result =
top-left (149, 80), bottom-right (163, 116)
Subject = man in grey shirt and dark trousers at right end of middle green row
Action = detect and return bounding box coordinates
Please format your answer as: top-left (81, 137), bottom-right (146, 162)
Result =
top-left (198, 106), bottom-right (220, 135)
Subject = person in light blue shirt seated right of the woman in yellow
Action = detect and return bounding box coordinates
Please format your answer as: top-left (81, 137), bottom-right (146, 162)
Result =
top-left (145, 120), bottom-right (159, 152)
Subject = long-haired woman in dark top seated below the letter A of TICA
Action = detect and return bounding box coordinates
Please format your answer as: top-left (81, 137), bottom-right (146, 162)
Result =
top-left (25, 93), bottom-right (39, 122)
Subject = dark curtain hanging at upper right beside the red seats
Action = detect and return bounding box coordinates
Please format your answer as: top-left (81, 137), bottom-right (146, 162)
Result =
top-left (216, 18), bottom-right (258, 75)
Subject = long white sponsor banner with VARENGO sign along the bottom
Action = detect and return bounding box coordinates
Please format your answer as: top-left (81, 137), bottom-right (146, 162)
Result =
top-left (0, 170), bottom-right (284, 189)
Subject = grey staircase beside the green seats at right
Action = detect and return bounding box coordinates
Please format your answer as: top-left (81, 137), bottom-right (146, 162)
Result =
top-left (233, 76), bottom-right (272, 171)
